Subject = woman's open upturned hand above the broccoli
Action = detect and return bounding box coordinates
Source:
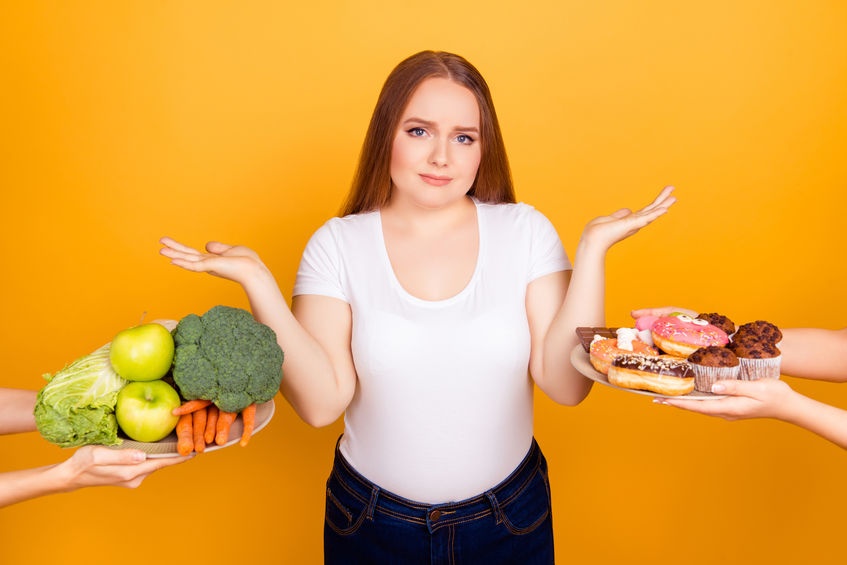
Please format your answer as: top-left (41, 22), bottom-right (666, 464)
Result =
top-left (159, 237), bottom-right (268, 286)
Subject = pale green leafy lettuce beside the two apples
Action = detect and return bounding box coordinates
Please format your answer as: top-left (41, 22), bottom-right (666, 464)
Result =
top-left (35, 343), bottom-right (127, 447)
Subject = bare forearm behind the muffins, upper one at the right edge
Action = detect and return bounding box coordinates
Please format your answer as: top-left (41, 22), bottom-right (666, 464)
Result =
top-left (779, 328), bottom-right (847, 382)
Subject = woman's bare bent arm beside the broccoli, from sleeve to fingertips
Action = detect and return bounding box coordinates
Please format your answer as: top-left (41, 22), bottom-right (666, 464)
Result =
top-left (161, 238), bottom-right (356, 426)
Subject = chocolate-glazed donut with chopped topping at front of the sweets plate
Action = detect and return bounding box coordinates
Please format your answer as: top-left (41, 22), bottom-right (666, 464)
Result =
top-left (608, 354), bottom-right (694, 396)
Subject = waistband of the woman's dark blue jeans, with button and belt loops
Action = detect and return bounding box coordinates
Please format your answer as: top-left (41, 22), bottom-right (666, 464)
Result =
top-left (332, 438), bottom-right (543, 530)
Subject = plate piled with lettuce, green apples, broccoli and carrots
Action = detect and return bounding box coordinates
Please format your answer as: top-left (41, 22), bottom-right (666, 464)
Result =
top-left (34, 305), bottom-right (283, 457)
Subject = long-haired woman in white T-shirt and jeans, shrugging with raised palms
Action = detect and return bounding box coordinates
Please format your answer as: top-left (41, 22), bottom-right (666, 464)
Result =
top-left (161, 51), bottom-right (674, 563)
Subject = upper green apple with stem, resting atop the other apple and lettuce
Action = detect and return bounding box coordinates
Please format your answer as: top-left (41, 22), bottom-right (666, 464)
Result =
top-left (109, 322), bottom-right (174, 381)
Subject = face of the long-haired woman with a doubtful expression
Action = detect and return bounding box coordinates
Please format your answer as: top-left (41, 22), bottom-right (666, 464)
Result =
top-left (391, 78), bottom-right (482, 208)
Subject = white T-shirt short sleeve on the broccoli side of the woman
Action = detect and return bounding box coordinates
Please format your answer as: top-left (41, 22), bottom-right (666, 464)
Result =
top-left (292, 222), bottom-right (349, 302)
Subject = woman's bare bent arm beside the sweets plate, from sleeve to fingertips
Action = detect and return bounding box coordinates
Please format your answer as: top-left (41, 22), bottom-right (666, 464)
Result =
top-left (526, 187), bottom-right (676, 406)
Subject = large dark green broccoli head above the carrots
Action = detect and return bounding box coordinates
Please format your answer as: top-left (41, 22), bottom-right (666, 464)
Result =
top-left (173, 306), bottom-right (283, 412)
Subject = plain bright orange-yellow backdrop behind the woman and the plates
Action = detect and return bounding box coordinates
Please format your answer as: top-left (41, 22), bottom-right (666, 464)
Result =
top-left (0, 0), bottom-right (847, 565)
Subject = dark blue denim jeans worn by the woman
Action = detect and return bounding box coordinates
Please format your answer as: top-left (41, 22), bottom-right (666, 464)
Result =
top-left (324, 439), bottom-right (554, 565)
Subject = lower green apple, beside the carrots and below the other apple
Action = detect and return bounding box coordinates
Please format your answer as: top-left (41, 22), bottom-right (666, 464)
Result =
top-left (115, 380), bottom-right (181, 442)
